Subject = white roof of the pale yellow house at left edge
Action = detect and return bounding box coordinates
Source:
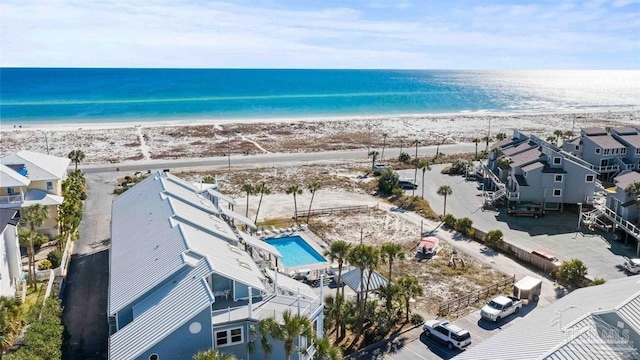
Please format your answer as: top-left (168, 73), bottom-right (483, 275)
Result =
top-left (0, 150), bottom-right (71, 181)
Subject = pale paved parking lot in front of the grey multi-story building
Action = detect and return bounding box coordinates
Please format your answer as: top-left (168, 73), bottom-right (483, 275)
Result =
top-left (398, 165), bottom-right (635, 280)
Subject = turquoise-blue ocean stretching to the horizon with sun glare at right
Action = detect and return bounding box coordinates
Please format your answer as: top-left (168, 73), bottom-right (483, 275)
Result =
top-left (0, 68), bottom-right (640, 126)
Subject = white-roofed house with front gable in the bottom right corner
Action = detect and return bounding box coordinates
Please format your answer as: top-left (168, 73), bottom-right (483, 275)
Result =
top-left (454, 277), bottom-right (640, 360)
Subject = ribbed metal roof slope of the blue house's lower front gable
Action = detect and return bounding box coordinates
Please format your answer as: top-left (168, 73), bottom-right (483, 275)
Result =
top-left (109, 259), bottom-right (213, 360)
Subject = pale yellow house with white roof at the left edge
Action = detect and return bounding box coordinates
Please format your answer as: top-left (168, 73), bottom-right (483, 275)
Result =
top-left (0, 150), bottom-right (71, 238)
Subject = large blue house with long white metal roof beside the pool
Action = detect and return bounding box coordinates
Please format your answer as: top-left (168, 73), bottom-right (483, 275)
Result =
top-left (107, 172), bottom-right (323, 360)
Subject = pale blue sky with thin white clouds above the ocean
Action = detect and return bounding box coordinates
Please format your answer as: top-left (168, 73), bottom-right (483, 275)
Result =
top-left (0, 0), bottom-right (640, 69)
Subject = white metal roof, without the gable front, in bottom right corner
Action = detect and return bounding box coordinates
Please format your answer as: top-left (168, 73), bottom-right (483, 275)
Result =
top-left (455, 277), bottom-right (640, 360)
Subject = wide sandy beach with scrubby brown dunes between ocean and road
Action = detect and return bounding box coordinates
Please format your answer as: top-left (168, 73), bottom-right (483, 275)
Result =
top-left (0, 110), bottom-right (640, 164)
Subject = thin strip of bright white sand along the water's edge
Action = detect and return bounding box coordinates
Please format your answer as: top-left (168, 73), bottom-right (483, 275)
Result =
top-left (0, 106), bottom-right (640, 133)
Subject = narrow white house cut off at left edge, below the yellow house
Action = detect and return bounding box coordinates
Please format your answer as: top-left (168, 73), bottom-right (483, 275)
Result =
top-left (0, 209), bottom-right (22, 297)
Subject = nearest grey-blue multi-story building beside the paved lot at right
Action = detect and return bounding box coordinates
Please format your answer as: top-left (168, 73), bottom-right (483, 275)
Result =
top-left (488, 131), bottom-right (597, 210)
